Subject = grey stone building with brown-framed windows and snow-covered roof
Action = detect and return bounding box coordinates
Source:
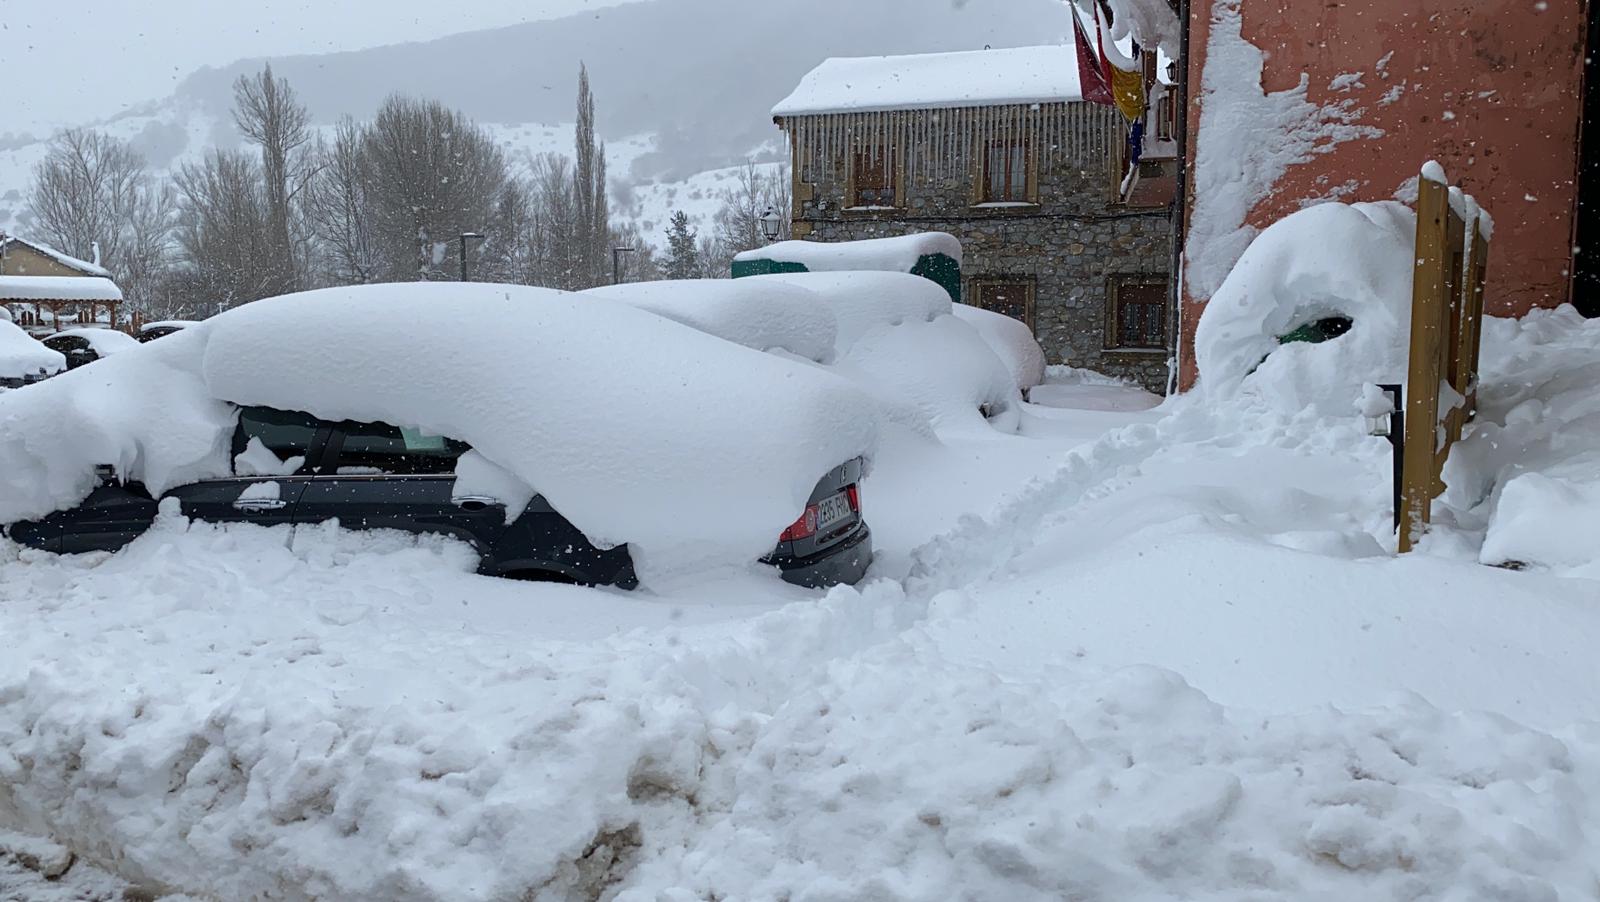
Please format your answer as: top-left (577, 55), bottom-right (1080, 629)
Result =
top-left (773, 45), bottom-right (1176, 392)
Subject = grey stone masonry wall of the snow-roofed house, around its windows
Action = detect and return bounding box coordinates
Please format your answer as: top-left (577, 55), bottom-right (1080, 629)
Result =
top-left (792, 107), bottom-right (1174, 393)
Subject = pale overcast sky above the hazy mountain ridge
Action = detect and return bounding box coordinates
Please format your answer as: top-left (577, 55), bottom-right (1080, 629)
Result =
top-left (0, 0), bottom-right (636, 136)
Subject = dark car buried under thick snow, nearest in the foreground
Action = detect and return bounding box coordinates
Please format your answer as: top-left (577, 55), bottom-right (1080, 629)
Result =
top-left (0, 285), bottom-right (875, 587)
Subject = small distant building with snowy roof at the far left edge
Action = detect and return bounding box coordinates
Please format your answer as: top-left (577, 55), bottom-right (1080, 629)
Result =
top-left (0, 233), bottom-right (122, 334)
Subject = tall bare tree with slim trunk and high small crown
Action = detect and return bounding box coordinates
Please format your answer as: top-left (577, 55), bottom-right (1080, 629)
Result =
top-left (234, 64), bottom-right (310, 294)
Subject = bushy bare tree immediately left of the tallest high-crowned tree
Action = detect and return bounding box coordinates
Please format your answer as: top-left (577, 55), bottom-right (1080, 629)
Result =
top-left (176, 150), bottom-right (282, 309)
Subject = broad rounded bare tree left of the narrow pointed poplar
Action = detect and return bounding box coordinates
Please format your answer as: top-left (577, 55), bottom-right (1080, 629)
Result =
top-left (362, 94), bottom-right (507, 281)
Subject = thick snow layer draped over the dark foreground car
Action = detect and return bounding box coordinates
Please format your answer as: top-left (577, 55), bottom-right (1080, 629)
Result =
top-left (0, 285), bottom-right (877, 577)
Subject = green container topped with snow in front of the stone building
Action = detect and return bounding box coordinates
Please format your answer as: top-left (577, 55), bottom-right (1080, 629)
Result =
top-left (733, 232), bottom-right (962, 304)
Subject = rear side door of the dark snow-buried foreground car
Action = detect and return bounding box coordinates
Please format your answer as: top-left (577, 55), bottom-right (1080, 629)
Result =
top-left (294, 421), bottom-right (506, 553)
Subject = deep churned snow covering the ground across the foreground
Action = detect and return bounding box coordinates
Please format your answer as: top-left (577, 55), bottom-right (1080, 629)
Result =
top-left (0, 310), bottom-right (1600, 902)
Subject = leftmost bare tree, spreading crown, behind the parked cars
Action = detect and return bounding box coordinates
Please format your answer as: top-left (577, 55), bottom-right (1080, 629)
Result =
top-left (30, 128), bottom-right (173, 310)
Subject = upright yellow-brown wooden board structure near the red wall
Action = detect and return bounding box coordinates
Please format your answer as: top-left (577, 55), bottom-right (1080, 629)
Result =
top-left (1397, 163), bottom-right (1491, 553)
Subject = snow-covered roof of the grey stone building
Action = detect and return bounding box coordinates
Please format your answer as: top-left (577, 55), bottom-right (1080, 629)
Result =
top-left (773, 45), bottom-right (1083, 117)
